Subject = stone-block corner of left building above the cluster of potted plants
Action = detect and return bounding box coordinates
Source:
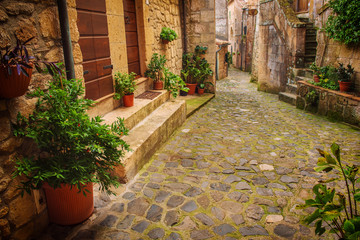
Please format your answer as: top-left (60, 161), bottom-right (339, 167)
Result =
top-left (185, 0), bottom-right (216, 93)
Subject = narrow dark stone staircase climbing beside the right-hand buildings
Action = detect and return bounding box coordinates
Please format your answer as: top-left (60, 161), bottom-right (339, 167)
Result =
top-left (279, 18), bottom-right (317, 106)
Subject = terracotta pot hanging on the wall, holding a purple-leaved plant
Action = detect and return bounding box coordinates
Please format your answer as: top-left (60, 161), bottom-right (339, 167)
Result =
top-left (0, 64), bottom-right (33, 98)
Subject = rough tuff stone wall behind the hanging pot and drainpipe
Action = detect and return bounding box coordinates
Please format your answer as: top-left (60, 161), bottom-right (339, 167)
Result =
top-left (0, 0), bottom-right (82, 239)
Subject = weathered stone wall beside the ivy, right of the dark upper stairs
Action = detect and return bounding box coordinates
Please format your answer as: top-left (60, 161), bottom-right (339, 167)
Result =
top-left (311, 0), bottom-right (360, 92)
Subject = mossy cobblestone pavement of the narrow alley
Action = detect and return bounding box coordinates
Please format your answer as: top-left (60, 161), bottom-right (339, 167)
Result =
top-left (42, 70), bottom-right (360, 240)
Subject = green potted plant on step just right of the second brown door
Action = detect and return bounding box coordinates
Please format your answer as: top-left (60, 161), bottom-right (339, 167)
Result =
top-left (145, 53), bottom-right (166, 90)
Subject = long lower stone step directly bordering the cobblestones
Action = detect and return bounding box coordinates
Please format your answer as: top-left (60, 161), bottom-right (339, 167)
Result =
top-left (114, 100), bottom-right (186, 182)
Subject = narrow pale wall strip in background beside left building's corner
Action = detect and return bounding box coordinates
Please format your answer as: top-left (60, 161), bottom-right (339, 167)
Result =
top-left (215, 0), bottom-right (228, 40)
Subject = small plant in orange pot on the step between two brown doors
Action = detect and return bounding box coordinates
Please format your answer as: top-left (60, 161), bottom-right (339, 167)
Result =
top-left (114, 72), bottom-right (137, 107)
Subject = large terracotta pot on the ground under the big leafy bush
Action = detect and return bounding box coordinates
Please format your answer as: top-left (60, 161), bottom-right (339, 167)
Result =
top-left (43, 182), bottom-right (94, 225)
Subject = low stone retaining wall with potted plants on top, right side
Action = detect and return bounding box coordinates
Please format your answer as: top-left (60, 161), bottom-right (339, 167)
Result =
top-left (296, 81), bottom-right (360, 126)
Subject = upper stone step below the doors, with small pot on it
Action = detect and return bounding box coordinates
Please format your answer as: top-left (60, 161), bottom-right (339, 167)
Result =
top-left (104, 90), bottom-right (170, 129)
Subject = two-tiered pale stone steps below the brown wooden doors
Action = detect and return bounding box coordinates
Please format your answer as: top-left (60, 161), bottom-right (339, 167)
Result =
top-left (103, 79), bottom-right (186, 183)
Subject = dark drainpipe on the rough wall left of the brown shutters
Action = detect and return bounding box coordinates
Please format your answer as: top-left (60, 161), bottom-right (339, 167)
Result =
top-left (57, 0), bottom-right (75, 79)
